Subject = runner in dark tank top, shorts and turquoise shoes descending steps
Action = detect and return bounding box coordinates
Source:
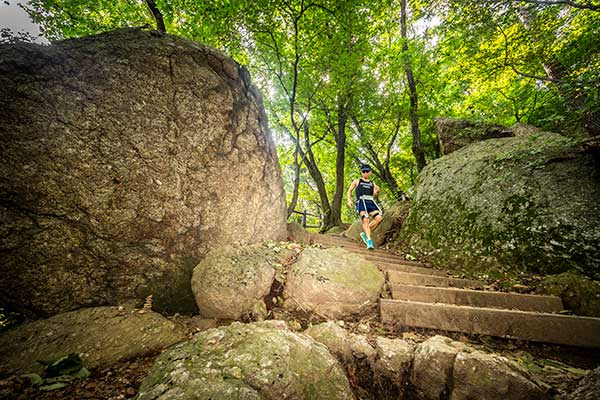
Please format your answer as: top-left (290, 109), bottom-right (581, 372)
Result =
top-left (348, 164), bottom-right (383, 249)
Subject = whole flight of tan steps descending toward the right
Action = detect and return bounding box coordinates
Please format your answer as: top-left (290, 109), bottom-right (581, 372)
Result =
top-left (313, 235), bottom-right (600, 348)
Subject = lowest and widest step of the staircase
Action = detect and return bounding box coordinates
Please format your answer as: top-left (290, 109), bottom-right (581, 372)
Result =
top-left (379, 299), bottom-right (600, 348)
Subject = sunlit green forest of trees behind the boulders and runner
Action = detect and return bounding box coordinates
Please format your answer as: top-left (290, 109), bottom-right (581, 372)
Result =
top-left (7, 0), bottom-right (600, 230)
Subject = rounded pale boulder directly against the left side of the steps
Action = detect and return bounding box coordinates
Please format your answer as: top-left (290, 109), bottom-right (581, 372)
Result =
top-left (283, 247), bottom-right (384, 319)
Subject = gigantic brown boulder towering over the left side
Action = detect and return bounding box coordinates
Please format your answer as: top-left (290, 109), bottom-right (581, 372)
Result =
top-left (0, 29), bottom-right (286, 315)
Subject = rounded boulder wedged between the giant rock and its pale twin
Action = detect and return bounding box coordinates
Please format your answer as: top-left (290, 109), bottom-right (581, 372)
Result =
top-left (192, 245), bottom-right (292, 319)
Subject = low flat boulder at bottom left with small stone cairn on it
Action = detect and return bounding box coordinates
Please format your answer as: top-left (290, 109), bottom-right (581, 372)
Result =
top-left (0, 307), bottom-right (187, 376)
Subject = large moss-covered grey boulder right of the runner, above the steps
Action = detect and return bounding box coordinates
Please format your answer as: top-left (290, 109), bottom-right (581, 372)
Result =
top-left (401, 133), bottom-right (600, 276)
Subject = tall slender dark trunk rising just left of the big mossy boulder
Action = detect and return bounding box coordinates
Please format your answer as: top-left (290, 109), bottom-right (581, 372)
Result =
top-left (400, 0), bottom-right (426, 172)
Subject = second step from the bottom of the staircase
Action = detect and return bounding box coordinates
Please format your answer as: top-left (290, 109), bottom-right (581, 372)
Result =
top-left (392, 284), bottom-right (563, 313)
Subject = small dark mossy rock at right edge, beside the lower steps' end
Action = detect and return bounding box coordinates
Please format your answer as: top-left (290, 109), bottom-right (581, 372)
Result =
top-left (536, 272), bottom-right (600, 317)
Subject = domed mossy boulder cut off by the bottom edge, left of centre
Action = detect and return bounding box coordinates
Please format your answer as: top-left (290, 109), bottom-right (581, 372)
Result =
top-left (138, 321), bottom-right (354, 400)
